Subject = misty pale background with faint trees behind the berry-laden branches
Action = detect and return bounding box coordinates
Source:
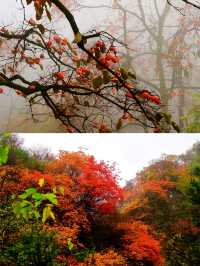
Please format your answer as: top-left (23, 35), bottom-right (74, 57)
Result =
top-left (0, 0), bottom-right (200, 132)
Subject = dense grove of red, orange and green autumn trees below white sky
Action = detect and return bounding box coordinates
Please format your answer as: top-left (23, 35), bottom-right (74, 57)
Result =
top-left (0, 134), bottom-right (200, 266)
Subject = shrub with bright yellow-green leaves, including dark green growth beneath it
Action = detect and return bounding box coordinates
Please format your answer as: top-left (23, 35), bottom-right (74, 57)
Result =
top-left (0, 178), bottom-right (61, 266)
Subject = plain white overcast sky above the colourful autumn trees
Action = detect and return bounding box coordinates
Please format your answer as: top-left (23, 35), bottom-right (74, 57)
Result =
top-left (18, 134), bottom-right (200, 185)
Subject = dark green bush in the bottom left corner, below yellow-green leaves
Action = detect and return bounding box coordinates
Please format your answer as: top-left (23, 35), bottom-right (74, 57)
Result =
top-left (0, 227), bottom-right (59, 266)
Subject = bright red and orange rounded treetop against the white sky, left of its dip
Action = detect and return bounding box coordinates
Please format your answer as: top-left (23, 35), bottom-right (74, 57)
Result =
top-left (47, 151), bottom-right (122, 214)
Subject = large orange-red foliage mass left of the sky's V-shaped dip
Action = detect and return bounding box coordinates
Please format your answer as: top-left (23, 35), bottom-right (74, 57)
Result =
top-left (0, 152), bottom-right (122, 252)
